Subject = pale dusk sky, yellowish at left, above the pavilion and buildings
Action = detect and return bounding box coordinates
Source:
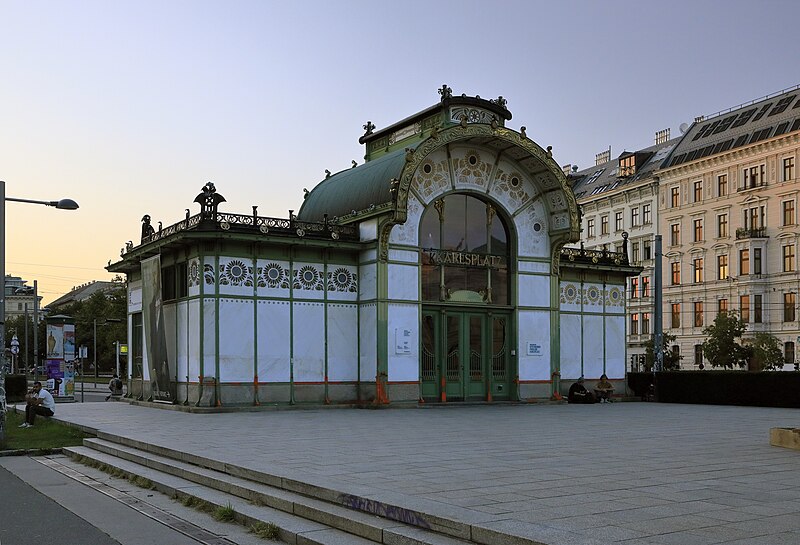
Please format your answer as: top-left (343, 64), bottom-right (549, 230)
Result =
top-left (0, 0), bottom-right (800, 304)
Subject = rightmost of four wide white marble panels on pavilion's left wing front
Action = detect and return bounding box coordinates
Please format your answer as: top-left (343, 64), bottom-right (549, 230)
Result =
top-left (328, 304), bottom-right (358, 382)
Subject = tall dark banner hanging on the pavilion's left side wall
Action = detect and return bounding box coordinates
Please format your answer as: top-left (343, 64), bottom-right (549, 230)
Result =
top-left (142, 256), bottom-right (177, 403)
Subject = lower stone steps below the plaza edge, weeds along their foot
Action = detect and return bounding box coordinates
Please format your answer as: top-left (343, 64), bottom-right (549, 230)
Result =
top-left (65, 439), bottom-right (470, 545)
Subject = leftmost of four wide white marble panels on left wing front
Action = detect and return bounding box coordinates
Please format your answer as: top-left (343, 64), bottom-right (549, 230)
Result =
top-left (219, 299), bottom-right (255, 383)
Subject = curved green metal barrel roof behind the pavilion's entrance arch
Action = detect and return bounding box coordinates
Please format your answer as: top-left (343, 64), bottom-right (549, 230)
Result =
top-left (297, 149), bottom-right (416, 221)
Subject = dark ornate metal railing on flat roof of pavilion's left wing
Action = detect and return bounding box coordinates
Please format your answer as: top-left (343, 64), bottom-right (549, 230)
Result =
top-left (141, 212), bottom-right (358, 244)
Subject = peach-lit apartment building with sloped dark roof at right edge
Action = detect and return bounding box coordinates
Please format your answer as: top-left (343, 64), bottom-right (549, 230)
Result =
top-left (656, 86), bottom-right (800, 369)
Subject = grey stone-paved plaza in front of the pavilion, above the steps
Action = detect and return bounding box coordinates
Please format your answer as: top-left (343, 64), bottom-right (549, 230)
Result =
top-left (43, 402), bottom-right (800, 545)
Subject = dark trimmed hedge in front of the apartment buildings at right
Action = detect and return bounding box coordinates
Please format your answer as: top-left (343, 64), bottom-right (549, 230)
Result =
top-left (628, 371), bottom-right (800, 408)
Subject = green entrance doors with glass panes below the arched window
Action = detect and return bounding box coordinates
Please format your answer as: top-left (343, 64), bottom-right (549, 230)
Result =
top-left (420, 309), bottom-right (512, 402)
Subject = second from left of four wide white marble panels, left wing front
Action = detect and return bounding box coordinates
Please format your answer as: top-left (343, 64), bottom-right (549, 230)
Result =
top-left (257, 301), bottom-right (292, 382)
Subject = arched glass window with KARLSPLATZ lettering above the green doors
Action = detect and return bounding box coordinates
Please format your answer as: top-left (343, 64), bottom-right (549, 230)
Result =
top-left (420, 194), bottom-right (509, 305)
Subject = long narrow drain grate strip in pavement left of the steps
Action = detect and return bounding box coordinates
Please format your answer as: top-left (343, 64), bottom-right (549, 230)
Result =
top-left (33, 457), bottom-right (236, 545)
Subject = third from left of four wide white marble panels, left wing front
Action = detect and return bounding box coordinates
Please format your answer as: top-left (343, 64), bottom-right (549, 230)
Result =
top-left (292, 303), bottom-right (325, 382)
